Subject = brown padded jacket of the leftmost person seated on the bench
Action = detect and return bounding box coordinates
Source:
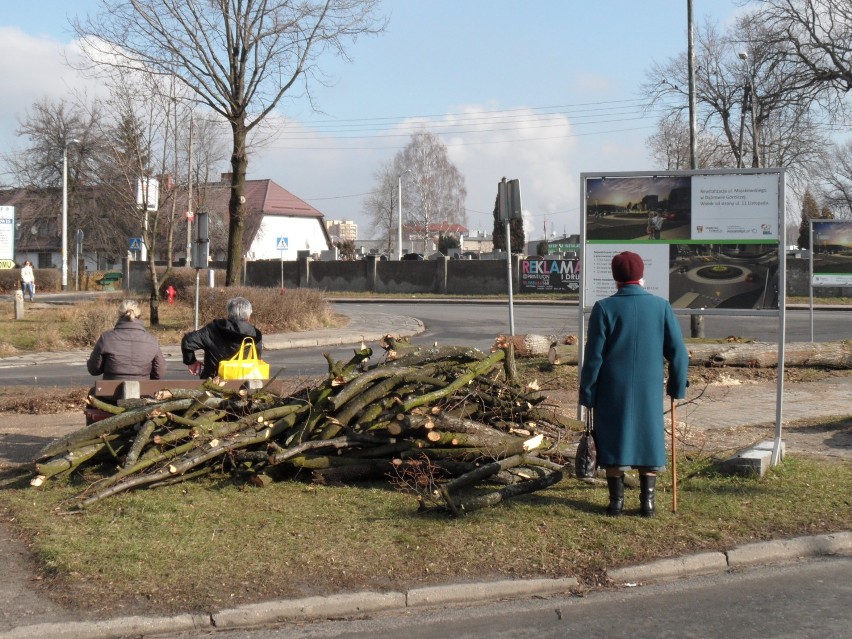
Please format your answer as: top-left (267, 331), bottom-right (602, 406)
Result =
top-left (86, 318), bottom-right (166, 379)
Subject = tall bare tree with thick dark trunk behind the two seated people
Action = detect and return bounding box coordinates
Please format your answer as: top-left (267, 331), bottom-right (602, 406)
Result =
top-left (74, 0), bottom-right (384, 285)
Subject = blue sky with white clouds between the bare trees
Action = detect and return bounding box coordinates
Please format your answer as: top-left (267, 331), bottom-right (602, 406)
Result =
top-left (0, 0), bottom-right (738, 239)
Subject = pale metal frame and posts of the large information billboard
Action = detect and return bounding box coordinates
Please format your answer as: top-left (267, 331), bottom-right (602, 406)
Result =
top-left (577, 168), bottom-right (787, 466)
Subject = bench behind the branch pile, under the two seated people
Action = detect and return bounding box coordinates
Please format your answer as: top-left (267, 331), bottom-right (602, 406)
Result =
top-left (85, 379), bottom-right (285, 424)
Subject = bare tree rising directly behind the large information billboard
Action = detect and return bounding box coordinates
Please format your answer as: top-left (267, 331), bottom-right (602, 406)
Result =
top-left (643, 14), bottom-right (831, 215)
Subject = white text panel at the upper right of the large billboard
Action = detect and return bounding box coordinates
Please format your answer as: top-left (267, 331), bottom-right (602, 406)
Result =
top-left (691, 174), bottom-right (779, 242)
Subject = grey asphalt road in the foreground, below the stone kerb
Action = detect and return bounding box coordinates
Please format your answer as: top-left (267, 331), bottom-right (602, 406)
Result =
top-left (181, 557), bottom-right (852, 639)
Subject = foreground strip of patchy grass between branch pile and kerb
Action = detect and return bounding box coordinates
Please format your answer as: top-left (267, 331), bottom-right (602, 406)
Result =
top-left (0, 457), bottom-right (852, 612)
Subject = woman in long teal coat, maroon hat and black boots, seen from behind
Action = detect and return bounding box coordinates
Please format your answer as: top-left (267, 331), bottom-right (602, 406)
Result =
top-left (580, 251), bottom-right (689, 517)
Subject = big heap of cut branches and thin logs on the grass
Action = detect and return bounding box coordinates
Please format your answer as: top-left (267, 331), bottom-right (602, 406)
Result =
top-left (31, 338), bottom-right (582, 514)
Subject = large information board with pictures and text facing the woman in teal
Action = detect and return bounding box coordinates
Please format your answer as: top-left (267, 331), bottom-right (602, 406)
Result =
top-left (581, 169), bottom-right (784, 310)
